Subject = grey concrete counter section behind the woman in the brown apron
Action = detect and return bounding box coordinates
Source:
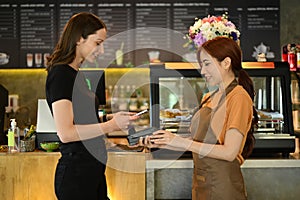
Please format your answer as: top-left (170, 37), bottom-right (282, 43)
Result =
top-left (146, 155), bottom-right (300, 200)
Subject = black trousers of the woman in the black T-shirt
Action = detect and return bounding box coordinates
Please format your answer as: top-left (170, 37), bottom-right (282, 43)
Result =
top-left (55, 152), bottom-right (108, 200)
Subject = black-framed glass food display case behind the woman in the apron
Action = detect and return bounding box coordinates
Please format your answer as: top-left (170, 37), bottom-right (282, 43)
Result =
top-left (150, 62), bottom-right (295, 156)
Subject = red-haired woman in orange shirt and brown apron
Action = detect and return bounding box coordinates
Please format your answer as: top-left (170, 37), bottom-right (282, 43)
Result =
top-left (146, 37), bottom-right (257, 200)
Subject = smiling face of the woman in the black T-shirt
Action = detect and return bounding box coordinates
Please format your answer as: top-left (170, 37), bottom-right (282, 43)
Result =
top-left (76, 28), bottom-right (106, 62)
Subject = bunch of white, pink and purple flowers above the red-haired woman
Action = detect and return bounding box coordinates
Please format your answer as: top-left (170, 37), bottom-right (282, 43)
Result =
top-left (187, 14), bottom-right (240, 47)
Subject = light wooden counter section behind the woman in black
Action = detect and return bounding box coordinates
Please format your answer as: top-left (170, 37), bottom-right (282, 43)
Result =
top-left (0, 152), bottom-right (146, 200)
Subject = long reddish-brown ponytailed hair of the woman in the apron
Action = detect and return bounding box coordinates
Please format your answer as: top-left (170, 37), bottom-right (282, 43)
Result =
top-left (197, 37), bottom-right (258, 158)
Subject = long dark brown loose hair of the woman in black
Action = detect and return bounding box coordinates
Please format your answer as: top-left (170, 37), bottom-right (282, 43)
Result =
top-left (46, 12), bottom-right (106, 71)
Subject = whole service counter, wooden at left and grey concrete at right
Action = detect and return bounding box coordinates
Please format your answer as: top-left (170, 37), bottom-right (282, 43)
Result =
top-left (0, 152), bottom-right (300, 200)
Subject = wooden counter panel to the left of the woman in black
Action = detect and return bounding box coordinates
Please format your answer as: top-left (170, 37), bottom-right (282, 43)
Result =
top-left (0, 153), bottom-right (60, 200)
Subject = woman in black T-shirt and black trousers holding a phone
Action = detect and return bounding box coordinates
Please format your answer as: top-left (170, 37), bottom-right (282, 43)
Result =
top-left (46, 13), bottom-right (137, 200)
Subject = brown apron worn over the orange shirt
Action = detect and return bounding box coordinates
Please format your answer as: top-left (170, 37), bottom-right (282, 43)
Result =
top-left (191, 80), bottom-right (247, 200)
